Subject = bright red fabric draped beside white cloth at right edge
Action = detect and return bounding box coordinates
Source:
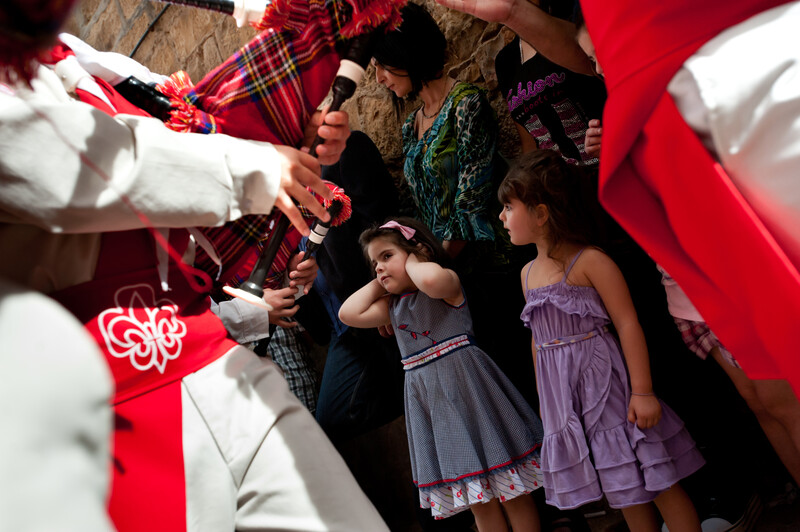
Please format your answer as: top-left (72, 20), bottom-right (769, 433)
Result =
top-left (581, 0), bottom-right (800, 392)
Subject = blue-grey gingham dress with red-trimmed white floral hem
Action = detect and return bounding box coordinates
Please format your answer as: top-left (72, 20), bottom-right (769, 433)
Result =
top-left (390, 292), bottom-right (542, 519)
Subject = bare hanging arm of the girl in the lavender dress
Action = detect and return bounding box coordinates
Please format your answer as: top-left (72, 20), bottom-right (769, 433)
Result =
top-left (581, 249), bottom-right (661, 428)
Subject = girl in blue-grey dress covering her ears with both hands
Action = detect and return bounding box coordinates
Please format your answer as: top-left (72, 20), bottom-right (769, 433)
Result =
top-left (339, 218), bottom-right (542, 532)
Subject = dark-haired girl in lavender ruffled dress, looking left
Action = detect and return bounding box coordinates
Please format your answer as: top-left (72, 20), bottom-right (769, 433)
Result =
top-left (498, 150), bottom-right (704, 532)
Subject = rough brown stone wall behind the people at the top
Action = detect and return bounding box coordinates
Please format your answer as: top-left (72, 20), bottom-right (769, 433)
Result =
top-left (67, 0), bottom-right (518, 187)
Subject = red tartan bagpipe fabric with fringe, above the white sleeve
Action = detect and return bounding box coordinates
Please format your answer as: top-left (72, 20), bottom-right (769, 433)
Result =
top-left (161, 0), bottom-right (405, 146)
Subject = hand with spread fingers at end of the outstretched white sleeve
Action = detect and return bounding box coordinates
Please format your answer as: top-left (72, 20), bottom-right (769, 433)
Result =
top-left (275, 146), bottom-right (333, 236)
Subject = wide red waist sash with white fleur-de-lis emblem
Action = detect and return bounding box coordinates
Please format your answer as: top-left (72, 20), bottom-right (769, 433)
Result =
top-left (54, 229), bottom-right (238, 405)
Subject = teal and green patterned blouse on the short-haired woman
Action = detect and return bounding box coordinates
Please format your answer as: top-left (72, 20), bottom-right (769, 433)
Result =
top-left (403, 82), bottom-right (497, 242)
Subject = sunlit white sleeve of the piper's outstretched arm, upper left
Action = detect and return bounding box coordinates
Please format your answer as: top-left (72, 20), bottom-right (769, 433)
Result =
top-left (0, 82), bottom-right (281, 232)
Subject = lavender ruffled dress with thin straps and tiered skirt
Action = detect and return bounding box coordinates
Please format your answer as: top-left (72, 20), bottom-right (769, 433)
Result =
top-left (521, 252), bottom-right (705, 509)
